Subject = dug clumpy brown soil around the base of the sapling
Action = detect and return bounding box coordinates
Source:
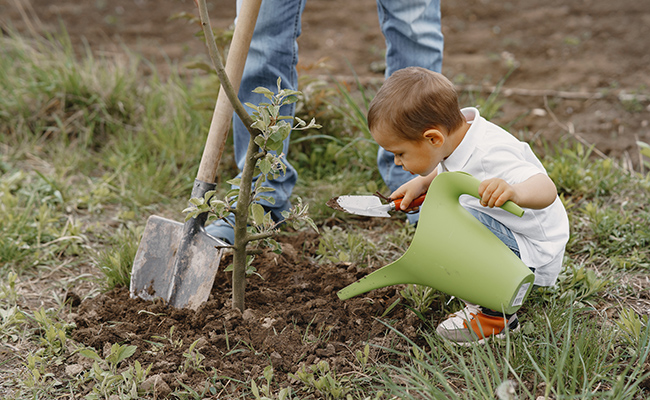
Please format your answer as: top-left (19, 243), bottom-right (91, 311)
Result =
top-left (72, 232), bottom-right (421, 390)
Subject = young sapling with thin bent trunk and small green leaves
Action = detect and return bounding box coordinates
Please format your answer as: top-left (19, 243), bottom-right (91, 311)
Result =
top-left (184, 0), bottom-right (320, 311)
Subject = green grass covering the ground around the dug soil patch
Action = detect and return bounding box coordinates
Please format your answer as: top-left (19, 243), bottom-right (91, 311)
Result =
top-left (0, 28), bottom-right (650, 399)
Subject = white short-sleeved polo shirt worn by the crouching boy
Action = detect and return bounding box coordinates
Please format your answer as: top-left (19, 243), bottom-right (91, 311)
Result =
top-left (438, 107), bottom-right (569, 286)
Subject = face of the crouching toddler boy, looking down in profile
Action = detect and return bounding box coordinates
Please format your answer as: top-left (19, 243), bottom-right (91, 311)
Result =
top-left (372, 125), bottom-right (445, 176)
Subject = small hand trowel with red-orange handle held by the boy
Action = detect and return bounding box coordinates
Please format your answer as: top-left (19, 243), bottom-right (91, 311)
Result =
top-left (327, 194), bottom-right (425, 218)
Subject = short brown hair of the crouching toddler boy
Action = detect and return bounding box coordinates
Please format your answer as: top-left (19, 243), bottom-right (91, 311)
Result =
top-left (368, 67), bottom-right (465, 140)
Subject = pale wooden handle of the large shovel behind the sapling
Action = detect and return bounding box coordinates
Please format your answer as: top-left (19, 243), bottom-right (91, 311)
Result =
top-left (196, 0), bottom-right (262, 183)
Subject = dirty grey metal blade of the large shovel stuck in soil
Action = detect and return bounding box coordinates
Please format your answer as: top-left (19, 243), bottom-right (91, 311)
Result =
top-left (130, 215), bottom-right (228, 310)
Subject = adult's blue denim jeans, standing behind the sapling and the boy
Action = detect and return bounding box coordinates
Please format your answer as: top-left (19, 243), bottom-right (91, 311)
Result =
top-left (233, 0), bottom-right (443, 222)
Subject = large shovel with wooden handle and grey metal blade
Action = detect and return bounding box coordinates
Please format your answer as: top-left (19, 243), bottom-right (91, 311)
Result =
top-left (130, 0), bottom-right (261, 309)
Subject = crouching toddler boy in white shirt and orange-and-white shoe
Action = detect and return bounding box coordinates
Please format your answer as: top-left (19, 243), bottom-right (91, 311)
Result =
top-left (368, 67), bottom-right (569, 345)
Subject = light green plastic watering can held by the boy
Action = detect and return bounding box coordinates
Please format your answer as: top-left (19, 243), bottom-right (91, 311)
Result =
top-left (337, 172), bottom-right (535, 314)
